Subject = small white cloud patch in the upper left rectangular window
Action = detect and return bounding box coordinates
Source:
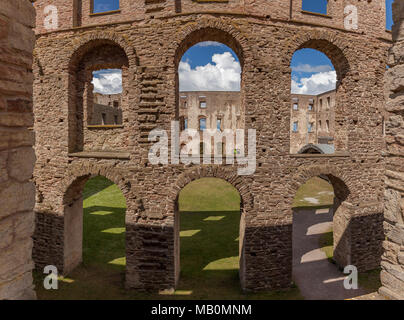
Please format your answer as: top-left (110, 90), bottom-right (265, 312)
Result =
top-left (92, 69), bottom-right (122, 94)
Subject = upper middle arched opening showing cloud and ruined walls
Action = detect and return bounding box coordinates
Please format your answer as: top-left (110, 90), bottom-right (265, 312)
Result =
top-left (175, 28), bottom-right (245, 156)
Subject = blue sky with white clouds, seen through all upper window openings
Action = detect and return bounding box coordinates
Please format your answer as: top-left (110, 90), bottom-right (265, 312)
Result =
top-left (94, 0), bottom-right (393, 94)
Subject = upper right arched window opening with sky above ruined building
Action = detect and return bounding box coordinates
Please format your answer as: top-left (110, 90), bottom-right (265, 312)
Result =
top-left (290, 48), bottom-right (339, 154)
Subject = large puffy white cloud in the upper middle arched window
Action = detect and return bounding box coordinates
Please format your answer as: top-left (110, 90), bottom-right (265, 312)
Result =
top-left (178, 52), bottom-right (241, 91)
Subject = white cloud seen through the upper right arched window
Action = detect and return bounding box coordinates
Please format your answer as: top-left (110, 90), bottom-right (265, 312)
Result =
top-left (292, 71), bottom-right (337, 95)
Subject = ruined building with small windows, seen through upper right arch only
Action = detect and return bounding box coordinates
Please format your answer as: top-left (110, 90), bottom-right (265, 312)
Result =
top-left (290, 90), bottom-right (335, 154)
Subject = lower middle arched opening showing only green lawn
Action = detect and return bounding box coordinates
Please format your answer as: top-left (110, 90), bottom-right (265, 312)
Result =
top-left (175, 178), bottom-right (244, 297)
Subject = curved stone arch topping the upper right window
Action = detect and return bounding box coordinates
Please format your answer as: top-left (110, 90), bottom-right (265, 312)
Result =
top-left (289, 33), bottom-right (351, 87)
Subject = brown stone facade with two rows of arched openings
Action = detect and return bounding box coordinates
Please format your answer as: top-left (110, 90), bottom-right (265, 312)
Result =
top-left (33, 0), bottom-right (391, 291)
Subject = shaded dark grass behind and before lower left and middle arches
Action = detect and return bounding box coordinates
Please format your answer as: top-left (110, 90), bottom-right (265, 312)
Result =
top-left (35, 206), bottom-right (301, 300)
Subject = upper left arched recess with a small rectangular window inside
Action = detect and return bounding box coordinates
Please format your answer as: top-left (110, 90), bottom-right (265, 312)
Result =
top-left (68, 40), bottom-right (129, 153)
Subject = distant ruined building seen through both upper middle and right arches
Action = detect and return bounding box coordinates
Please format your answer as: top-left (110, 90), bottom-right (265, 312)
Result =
top-left (179, 90), bottom-right (335, 154)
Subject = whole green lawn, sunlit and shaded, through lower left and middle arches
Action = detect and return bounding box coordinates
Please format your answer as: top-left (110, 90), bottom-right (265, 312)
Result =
top-left (34, 177), bottom-right (302, 299)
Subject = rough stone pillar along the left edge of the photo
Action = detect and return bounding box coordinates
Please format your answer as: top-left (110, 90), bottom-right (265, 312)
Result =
top-left (0, 0), bottom-right (35, 300)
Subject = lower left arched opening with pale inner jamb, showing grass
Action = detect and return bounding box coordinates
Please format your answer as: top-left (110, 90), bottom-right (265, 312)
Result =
top-left (64, 175), bottom-right (126, 284)
